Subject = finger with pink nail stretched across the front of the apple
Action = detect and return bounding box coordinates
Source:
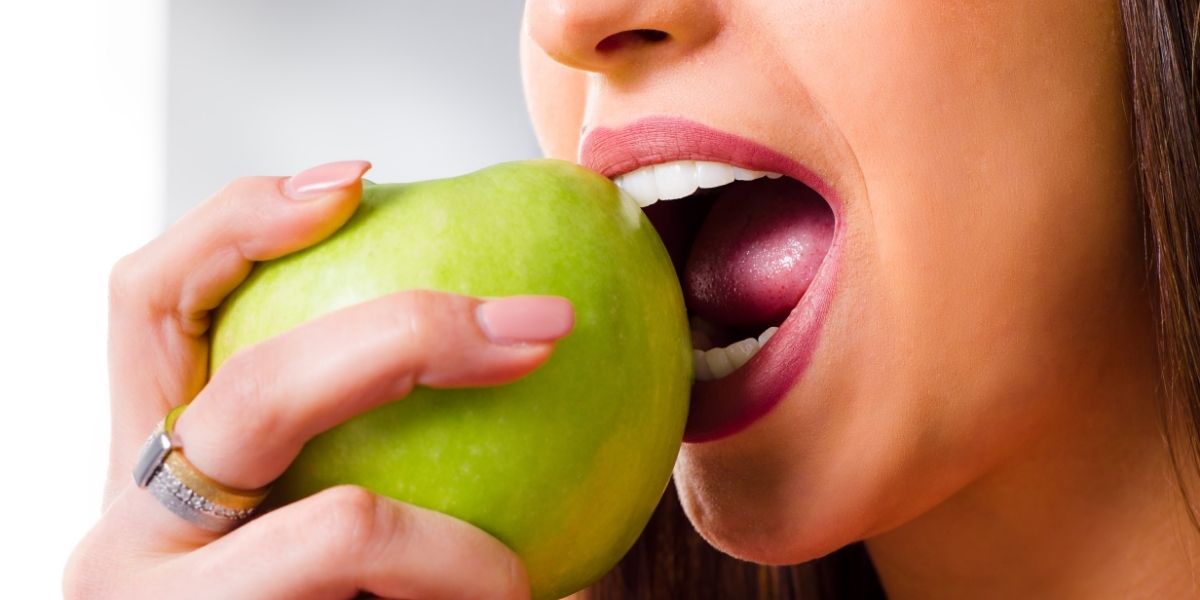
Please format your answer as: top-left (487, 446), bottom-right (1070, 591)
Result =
top-left (175, 292), bottom-right (574, 490)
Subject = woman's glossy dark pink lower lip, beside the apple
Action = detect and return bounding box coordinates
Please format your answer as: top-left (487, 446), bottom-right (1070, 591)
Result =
top-left (684, 208), bottom-right (842, 443)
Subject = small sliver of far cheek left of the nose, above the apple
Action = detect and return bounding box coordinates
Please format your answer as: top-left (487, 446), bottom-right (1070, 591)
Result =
top-left (521, 28), bottom-right (587, 161)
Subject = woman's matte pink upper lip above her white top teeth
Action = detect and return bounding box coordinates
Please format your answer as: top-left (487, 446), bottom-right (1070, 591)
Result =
top-left (580, 116), bottom-right (839, 212)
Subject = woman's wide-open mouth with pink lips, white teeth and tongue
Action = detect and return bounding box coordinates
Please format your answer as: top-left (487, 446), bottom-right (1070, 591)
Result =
top-left (581, 116), bottom-right (840, 443)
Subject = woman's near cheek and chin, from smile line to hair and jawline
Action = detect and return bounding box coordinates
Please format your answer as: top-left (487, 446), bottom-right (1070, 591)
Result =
top-left (678, 0), bottom-right (1137, 562)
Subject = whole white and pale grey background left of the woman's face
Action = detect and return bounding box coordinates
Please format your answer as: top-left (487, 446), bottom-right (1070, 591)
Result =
top-left (0, 0), bottom-right (536, 598)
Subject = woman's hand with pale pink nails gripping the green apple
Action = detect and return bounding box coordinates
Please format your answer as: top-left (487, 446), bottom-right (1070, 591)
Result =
top-left (65, 162), bottom-right (574, 599)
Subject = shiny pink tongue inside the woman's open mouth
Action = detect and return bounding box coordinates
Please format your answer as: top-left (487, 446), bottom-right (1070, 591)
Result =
top-left (684, 179), bottom-right (833, 332)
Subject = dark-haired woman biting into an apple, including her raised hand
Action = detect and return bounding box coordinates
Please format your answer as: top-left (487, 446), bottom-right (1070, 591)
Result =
top-left (66, 0), bottom-right (1200, 598)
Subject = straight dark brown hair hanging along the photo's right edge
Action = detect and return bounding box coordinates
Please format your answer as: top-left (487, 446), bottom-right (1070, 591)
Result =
top-left (1121, 0), bottom-right (1200, 528)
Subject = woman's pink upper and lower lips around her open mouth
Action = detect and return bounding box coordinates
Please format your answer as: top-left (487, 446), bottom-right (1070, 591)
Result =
top-left (580, 116), bottom-right (842, 443)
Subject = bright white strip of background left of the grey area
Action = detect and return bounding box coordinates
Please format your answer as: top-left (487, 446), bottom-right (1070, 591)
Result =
top-left (0, 0), bottom-right (166, 599)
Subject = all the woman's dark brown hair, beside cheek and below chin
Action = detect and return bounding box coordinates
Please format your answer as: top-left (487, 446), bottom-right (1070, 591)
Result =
top-left (590, 0), bottom-right (1200, 600)
